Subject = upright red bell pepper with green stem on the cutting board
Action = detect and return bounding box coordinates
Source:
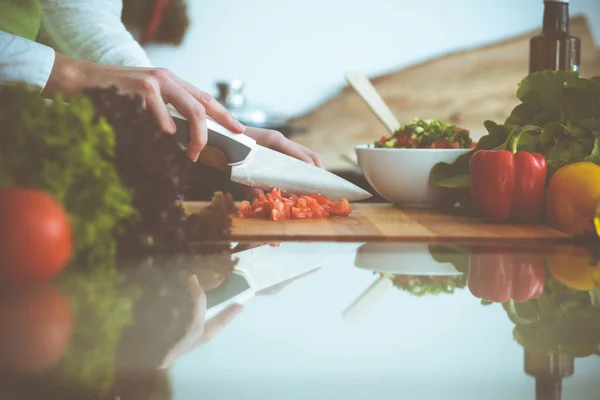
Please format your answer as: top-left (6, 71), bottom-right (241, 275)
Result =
top-left (470, 127), bottom-right (547, 222)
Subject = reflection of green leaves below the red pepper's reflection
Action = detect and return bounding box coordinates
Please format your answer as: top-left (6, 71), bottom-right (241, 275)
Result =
top-left (503, 276), bottom-right (600, 357)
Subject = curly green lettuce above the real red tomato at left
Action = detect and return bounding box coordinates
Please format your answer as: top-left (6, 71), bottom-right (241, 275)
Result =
top-left (0, 85), bottom-right (134, 265)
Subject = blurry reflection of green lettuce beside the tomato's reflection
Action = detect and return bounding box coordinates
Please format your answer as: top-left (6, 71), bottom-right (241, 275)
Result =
top-left (52, 267), bottom-right (139, 394)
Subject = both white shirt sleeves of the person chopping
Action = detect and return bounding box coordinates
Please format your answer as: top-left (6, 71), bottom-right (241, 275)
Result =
top-left (0, 0), bottom-right (152, 88)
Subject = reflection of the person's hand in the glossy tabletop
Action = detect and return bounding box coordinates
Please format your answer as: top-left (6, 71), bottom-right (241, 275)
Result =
top-left (160, 275), bottom-right (243, 369)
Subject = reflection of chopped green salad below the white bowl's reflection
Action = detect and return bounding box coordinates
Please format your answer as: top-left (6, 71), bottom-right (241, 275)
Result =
top-left (381, 273), bottom-right (467, 296)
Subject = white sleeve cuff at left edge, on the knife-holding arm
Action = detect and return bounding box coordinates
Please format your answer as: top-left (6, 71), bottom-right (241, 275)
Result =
top-left (0, 31), bottom-right (55, 89)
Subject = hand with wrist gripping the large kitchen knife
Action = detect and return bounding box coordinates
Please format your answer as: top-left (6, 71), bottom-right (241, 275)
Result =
top-left (43, 53), bottom-right (245, 161)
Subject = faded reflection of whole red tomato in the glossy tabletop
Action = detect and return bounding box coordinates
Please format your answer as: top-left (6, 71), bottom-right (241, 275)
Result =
top-left (0, 282), bottom-right (73, 373)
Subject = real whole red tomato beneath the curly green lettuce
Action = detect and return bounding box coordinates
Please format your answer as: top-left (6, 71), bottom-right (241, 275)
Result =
top-left (0, 189), bottom-right (73, 281)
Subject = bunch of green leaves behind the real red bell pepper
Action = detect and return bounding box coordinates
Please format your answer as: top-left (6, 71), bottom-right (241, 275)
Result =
top-left (432, 71), bottom-right (600, 195)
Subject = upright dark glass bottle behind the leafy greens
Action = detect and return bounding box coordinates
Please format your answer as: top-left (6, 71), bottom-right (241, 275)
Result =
top-left (529, 0), bottom-right (581, 74)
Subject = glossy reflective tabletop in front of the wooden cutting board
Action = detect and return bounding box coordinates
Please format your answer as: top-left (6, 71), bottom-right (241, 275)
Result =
top-left (0, 242), bottom-right (600, 400)
